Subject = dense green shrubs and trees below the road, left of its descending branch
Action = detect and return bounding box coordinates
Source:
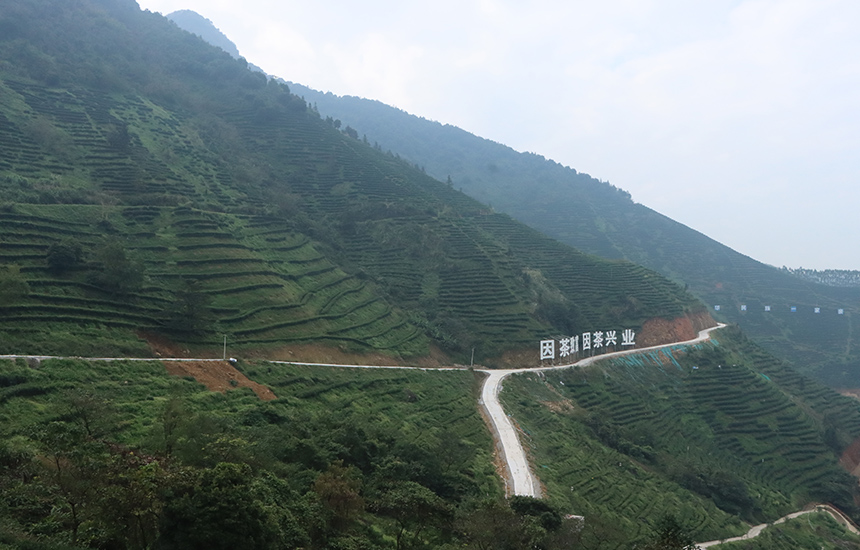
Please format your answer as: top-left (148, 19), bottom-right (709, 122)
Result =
top-left (0, 360), bottom-right (712, 550)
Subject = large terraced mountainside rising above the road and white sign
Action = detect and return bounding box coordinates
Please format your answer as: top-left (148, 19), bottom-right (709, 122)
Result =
top-left (0, 0), bottom-right (710, 361)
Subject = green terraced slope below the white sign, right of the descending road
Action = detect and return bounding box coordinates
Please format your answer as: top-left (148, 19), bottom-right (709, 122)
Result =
top-left (502, 330), bottom-right (860, 540)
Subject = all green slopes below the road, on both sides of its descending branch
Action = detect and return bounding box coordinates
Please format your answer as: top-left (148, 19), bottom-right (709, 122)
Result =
top-left (0, 331), bottom-right (860, 550)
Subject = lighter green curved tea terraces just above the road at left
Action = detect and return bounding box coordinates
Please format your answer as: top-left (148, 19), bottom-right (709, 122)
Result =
top-left (0, 205), bottom-right (426, 354)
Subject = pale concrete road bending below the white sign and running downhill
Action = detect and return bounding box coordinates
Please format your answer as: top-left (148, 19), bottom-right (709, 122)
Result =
top-left (479, 324), bottom-right (726, 498)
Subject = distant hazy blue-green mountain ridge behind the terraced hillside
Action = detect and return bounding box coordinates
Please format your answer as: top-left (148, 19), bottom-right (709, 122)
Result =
top-left (289, 82), bottom-right (860, 387)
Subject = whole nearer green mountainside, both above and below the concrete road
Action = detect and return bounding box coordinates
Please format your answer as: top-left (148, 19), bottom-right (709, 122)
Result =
top-left (5, 0), bottom-right (860, 550)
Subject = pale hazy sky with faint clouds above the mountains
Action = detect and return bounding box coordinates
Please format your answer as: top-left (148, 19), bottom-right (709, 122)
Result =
top-left (138, 0), bottom-right (860, 269)
